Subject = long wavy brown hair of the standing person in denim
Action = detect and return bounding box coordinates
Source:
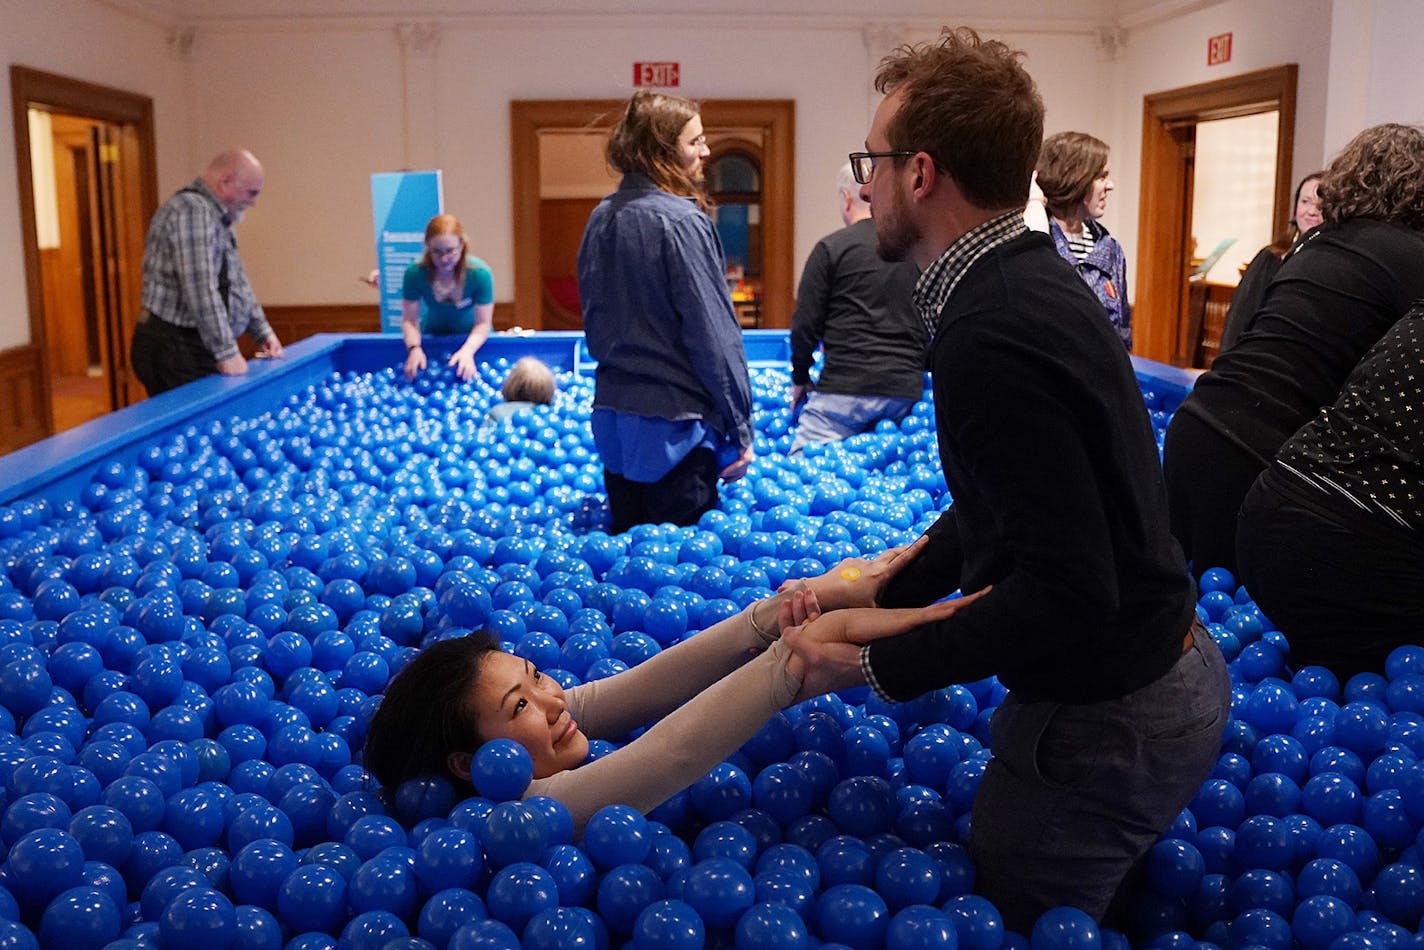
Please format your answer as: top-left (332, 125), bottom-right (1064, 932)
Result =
top-left (605, 90), bottom-right (712, 211)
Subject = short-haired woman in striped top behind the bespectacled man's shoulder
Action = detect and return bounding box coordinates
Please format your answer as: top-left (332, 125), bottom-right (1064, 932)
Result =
top-left (1038, 132), bottom-right (1132, 350)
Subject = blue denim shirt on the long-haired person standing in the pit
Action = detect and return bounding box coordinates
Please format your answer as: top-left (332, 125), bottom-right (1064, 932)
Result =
top-left (578, 174), bottom-right (752, 447)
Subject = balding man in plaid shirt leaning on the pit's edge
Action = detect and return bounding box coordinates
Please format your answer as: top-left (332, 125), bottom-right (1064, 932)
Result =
top-left (130, 148), bottom-right (282, 396)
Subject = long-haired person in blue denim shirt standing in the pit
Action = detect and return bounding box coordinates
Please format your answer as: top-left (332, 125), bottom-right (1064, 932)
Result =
top-left (578, 90), bottom-right (753, 533)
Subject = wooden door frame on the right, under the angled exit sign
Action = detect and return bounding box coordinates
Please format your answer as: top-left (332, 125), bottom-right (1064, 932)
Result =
top-left (1132, 63), bottom-right (1299, 366)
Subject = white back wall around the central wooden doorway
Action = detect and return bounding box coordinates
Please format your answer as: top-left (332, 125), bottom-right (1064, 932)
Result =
top-left (189, 17), bottom-right (1104, 311)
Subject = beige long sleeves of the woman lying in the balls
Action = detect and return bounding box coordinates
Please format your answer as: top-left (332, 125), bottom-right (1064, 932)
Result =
top-left (524, 604), bottom-right (800, 833)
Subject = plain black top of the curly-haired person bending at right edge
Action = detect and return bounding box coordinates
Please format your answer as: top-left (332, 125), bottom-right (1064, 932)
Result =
top-left (1178, 218), bottom-right (1424, 467)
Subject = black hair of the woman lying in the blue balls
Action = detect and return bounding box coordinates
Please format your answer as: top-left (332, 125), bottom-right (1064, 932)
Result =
top-left (362, 631), bottom-right (498, 795)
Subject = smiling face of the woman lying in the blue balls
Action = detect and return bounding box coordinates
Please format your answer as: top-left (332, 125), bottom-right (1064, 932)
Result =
top-left (473, 651), bottom-right (588, 779)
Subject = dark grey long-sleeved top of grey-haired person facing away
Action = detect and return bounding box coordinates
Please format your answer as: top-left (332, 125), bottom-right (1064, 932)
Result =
top-left (792, 218), bottom-right (926, 399)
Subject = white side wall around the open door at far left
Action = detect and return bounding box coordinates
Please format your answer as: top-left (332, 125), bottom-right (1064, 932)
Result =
top-left (0, 0), bottom-right (187, 350)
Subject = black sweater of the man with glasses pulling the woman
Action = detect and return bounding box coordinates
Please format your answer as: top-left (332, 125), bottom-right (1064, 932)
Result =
top-left (869, 232), bottom-right (1195, 702)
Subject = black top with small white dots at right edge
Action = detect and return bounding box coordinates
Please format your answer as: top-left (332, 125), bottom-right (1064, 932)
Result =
top-left (1276, 306), bottom-right (1424, 531)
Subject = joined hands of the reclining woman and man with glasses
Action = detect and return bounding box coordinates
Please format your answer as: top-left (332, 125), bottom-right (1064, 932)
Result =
top-left (776, 537), bottom-right (990, 702)
